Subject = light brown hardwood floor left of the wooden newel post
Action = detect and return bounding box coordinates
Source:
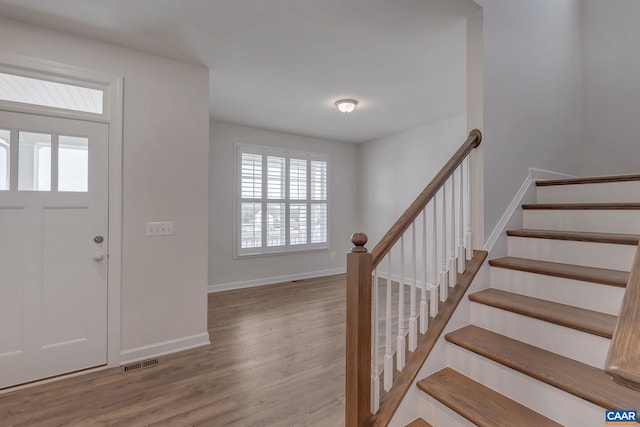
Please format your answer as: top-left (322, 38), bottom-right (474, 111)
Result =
top-left (0, 275), bottom-right (345, 427)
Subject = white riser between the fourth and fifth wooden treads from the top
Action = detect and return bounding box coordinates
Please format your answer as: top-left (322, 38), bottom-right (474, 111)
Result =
top-left (490, 267), bottom-right (625, 316)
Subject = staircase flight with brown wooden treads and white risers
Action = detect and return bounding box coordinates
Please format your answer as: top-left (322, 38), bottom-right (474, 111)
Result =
top-left (412, 175), bottom-right (640, 427)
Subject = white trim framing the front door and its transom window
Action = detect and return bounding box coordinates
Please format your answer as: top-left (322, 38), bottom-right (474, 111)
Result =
top-left (0, 52), bottom-right (124, 367)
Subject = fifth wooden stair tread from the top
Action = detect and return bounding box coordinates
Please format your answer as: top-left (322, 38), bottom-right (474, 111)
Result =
top-left (469, 289), bottom-right (617, 338)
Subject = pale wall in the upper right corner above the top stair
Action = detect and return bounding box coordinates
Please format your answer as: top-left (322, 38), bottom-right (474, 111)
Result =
top-left (582, 0), bottom-right (640, 175)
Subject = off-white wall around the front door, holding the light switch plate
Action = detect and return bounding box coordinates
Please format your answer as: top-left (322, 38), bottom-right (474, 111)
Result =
top-left (0, 18), bottom-right (209, 354)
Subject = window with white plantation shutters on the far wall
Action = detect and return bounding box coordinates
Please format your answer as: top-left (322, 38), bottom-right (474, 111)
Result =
top-left (235, 144), bottom-right (329, 256)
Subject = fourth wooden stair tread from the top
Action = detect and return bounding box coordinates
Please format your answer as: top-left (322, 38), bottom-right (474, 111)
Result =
top-left (489, 257), bottom-right (629, 288)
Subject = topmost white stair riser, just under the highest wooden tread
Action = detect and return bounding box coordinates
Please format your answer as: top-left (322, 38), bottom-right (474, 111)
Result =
top-left (536, 181), bottom-right (640, 203)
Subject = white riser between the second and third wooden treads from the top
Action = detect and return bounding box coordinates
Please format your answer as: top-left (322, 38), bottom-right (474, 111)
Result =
top-left (523, 209), bottom-right (640, 234)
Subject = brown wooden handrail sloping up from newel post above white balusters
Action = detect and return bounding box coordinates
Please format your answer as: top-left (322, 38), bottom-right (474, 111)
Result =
top-left (371, 129), bottom-right (482, 268)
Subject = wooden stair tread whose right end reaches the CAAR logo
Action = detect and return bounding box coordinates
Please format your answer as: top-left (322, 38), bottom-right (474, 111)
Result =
top-left (446, 325), bottom-right (640, 409)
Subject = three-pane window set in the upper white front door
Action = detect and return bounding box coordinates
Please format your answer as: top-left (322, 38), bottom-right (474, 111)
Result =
top-left (0, 128), bottom-right (89, 192)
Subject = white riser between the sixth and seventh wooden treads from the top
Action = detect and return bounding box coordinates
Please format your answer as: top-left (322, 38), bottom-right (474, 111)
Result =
top-left (447, 344), bottom-right (604, 426)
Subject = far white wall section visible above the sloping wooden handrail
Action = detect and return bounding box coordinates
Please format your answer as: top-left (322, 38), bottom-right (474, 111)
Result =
top-left (358, 114), bottom-right (467, 250)
